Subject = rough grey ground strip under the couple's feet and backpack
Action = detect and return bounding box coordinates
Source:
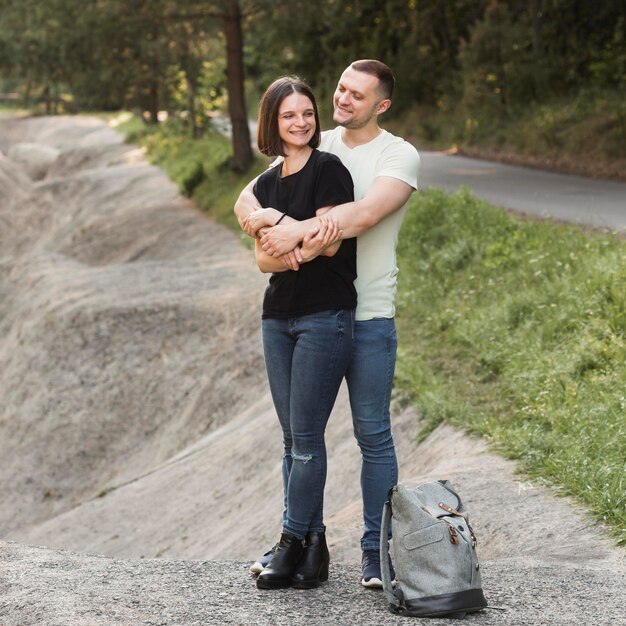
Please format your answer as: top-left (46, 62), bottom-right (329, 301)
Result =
top-left (0, 541), bottom-right (626, 626)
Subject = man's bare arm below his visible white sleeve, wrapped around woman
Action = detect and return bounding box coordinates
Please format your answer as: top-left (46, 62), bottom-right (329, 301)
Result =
top-left (261, 176), bottom-right (415, 256)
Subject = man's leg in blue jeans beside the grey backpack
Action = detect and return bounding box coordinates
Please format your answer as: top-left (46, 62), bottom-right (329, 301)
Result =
top-left (346, 318), bottom-right (398, 585)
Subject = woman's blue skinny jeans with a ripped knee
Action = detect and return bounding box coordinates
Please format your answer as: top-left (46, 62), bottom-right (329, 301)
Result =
top-left (262, 309), bottom-right (354, 538)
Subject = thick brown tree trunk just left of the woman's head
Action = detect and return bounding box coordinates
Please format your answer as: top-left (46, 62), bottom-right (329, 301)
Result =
top-left (224, 0), bottom-right (252, 172)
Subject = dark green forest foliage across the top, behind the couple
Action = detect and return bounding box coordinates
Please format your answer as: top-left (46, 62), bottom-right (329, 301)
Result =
top-left (0, 0), bottom-right (626, 121)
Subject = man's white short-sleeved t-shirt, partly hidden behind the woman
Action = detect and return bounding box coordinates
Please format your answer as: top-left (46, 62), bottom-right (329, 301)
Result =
top-left (319, 126), bottom-right (420, 320)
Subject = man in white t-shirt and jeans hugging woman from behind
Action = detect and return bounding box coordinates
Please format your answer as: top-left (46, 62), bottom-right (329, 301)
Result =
top-left (235, 60), bottom-right (419, 587)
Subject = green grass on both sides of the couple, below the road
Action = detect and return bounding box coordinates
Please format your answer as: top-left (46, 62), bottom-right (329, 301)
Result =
top-left (121, 121), bottom-right (626, 544)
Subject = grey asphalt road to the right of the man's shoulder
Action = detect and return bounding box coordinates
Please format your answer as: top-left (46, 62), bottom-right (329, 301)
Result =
top-left (420, 151), bottom-right (626, 232)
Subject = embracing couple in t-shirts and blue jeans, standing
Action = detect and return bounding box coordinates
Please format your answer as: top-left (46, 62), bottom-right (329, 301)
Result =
top-left (235, 60), bottom-right (419, 589)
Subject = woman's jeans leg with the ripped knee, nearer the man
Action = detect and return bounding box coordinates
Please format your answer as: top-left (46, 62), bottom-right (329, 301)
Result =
top-left (284, 310), bottom-right (354, 537)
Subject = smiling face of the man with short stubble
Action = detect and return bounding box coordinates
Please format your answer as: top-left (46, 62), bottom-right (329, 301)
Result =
top-left (333, 67), bottom-right (384, 129)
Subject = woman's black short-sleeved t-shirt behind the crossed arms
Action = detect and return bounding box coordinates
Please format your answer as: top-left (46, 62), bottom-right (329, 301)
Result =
top-left (254, 150), bottom-right (356, 318)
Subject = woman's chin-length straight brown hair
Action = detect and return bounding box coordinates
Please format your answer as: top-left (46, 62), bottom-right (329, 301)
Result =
top-left (256, 76), bottom-right (321, 156)
